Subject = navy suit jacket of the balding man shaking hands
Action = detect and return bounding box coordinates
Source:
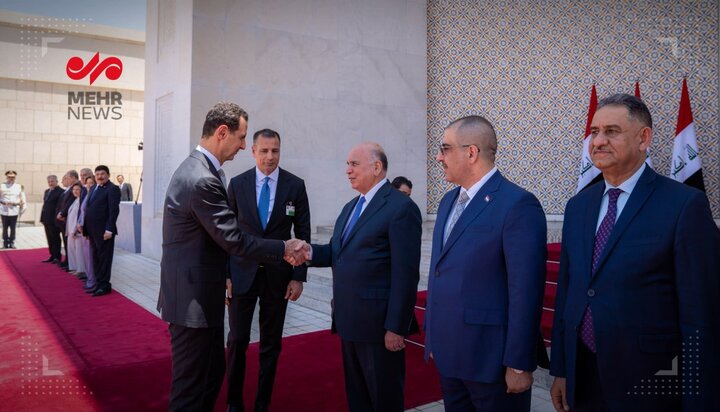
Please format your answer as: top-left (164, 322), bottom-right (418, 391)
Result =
top-left (310, 182), bottom-right (422, 343)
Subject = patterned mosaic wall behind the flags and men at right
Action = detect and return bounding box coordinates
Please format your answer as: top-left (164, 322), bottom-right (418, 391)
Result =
top-left (428, 0), bottom-right (720, 218)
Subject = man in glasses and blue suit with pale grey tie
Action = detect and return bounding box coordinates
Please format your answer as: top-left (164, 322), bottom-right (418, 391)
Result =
top-left (424, 116), bottom-right (547, 412)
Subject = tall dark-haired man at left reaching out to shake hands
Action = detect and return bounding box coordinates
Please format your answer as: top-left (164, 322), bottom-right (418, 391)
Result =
top-left (157, 103), bottom-right (304, 411)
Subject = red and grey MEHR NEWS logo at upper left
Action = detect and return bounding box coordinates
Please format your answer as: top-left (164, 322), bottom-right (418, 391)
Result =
top-left (65, 52), bottom-right (122, 120)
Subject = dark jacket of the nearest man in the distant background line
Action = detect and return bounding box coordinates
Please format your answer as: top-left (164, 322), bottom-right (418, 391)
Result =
top-left (83, 180), bottom-right (120, 239)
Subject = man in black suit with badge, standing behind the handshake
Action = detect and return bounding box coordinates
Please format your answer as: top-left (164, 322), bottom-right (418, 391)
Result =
top-left (227, 129), bottom-right (311, 411)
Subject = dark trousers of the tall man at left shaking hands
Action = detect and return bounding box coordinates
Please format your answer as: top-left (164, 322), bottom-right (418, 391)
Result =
top-left (168, 323), bottom-right (225, 412)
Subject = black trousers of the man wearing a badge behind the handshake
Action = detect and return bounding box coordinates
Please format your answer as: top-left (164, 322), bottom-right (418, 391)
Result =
top-left (228, 268), bottom-right (288, 410)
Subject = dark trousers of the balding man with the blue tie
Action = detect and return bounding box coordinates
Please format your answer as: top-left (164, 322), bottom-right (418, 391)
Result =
top-left (342, 339), bottom-right (405, 412)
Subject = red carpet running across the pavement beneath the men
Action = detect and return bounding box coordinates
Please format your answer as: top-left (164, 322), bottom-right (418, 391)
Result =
top-left (0, 246), bottom-right (441, 411)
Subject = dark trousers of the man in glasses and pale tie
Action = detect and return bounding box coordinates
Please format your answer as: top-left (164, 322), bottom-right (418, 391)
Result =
top-left (440, 375), bottom-right (532, 412)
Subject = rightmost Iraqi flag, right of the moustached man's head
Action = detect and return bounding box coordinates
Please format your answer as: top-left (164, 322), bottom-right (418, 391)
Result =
top-left (670, 79), bottom-right (705, 192)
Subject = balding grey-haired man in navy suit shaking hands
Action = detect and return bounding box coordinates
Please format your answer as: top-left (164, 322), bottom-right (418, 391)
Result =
top-left (311, 143), bottom-right (422, 411)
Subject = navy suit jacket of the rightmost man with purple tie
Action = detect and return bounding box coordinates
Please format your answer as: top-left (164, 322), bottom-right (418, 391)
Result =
top-left (550, 167), bottom-right (720, 411)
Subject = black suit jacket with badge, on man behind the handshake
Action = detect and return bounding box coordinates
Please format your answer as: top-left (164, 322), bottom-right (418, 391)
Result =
top-left (228, 167), bottom-right (311, 294)
